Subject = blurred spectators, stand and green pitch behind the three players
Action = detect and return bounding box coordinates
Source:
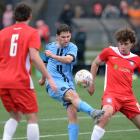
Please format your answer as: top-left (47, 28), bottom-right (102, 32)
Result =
top-left (0, 0), bottom-right (140, 140)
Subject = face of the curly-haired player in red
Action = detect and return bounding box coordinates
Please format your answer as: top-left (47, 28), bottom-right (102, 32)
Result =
top-left (118, 41), bottom-right (133, 55)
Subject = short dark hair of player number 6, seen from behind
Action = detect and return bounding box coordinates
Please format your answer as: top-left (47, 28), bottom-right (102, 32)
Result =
top-left (14, 3), bottom-right (32, 21)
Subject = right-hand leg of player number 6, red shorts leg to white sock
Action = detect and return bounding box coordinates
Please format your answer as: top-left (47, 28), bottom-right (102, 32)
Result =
top-left (20, 90), bottom-right (39, 140)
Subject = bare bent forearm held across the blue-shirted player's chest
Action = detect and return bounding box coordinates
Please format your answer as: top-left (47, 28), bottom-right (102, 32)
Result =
top-left (45, 50), bottom-right (74, 63)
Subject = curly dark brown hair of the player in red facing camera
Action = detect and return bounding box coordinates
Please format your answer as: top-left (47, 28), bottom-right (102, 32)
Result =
top-left (115, 28), bottom-right (136, 44)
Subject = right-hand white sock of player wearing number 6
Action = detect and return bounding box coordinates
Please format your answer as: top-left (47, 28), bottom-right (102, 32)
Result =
top-left (27, 123), bottom-right (39, 140)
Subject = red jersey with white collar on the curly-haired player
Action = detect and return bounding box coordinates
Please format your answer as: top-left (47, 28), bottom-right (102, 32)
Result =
top-left (99, 46), bottom-right (140, 95)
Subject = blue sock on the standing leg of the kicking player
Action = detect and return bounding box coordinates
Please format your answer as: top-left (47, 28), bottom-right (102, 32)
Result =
top-left (68, 123), bottom-right (79, 140)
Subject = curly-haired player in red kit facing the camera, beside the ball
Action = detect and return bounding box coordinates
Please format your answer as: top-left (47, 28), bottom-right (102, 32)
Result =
top-left (88, 28), bottom-right (140, 140)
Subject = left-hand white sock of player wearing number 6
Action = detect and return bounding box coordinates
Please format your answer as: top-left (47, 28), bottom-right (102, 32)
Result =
top-left (2, 118), bottom-right (18, 140)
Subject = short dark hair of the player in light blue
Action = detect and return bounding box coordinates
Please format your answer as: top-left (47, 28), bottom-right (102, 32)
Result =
top-left (56, 24), bottom-right (72, 35)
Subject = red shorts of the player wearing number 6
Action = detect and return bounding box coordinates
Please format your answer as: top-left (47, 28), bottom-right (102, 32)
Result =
top-left (0, 89), bottom-right (38, 114)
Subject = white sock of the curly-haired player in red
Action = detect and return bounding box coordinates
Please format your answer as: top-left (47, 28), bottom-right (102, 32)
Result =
top-left (91, 125), bottom-right (105, 140)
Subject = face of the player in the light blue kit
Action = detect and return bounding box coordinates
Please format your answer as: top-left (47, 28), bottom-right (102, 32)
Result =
top-left (57, 32), bottom-right (71, 47)
